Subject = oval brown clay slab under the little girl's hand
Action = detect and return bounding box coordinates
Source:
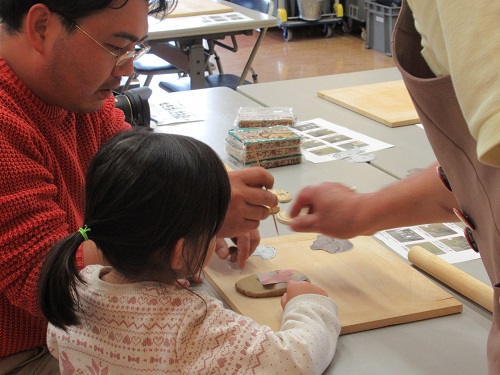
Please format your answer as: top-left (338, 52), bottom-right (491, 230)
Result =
top-left (235, 270), bottom-right (310, 298)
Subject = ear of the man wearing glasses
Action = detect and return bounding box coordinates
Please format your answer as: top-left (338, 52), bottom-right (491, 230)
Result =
top-left (23, 4), bottom-right (57, 53)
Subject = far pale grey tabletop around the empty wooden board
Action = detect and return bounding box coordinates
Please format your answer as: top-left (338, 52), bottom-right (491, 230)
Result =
top-left (238, 68), bottom-right (435, 179)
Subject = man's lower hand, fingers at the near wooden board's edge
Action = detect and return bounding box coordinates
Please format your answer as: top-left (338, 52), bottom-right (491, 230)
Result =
top-left (215, 229), bottom-right (260, 268)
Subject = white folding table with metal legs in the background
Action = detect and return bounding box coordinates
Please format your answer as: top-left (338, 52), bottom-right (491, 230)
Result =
top-left (149, 0), bottom-right (278, 89)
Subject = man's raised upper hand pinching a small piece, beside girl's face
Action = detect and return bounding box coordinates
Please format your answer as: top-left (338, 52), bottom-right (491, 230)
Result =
top-left (218, 167), bottom-right (278, 238)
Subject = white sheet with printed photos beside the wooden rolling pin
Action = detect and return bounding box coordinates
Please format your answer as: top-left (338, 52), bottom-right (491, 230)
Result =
top-left (375, 223), bottom-right (479, 263)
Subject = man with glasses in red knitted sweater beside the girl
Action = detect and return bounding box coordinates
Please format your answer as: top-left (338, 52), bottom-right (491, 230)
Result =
top-left (0, 0), bottom-right (276, 374)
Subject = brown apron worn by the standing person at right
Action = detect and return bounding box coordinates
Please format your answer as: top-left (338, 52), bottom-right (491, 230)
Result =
top-left (393, 1), bottom-right (500, 374)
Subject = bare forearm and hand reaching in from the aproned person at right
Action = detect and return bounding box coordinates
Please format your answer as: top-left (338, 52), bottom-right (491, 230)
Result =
top-left (290, 163), bottom-right (458, 239)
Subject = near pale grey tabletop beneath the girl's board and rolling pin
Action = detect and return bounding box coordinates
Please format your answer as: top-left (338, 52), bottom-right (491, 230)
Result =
top-left (150, 88), bottom-right (492, 375)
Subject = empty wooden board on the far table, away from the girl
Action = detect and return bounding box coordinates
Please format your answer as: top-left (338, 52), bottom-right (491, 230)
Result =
top-left (318, 80), bottom-right (420, 127)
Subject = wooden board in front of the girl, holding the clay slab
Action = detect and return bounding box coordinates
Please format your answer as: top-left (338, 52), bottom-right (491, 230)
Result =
top-left (205, 233), bottom-right (462, 334)
